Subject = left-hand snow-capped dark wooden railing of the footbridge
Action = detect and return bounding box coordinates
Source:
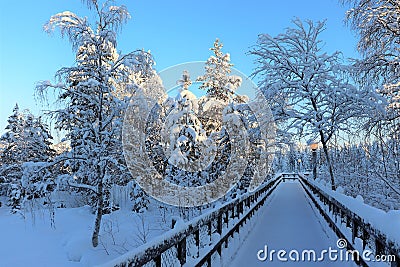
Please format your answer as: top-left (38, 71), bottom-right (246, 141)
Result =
top-left (97, 175), bottom-right (284, 267)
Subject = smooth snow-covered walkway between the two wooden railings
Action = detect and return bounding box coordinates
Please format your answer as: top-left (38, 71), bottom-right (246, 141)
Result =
top-left (229, 181), bottom-right (356, 267)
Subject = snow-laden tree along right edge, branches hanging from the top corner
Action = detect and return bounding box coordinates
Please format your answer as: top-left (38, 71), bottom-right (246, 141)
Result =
top-left (341, 0), bottom-right (400, 197)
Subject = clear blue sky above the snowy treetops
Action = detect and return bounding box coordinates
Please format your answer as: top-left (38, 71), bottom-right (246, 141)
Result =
top-left (0, 0), bottom-right (358, 137)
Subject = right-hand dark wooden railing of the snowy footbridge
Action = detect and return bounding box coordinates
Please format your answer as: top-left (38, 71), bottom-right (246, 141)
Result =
top-left (300, 176), bottom-right (400, 267)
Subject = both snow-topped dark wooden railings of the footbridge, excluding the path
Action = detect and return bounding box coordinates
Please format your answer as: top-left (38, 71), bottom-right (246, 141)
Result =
top-left (103, 173), bottom-right (400, 267)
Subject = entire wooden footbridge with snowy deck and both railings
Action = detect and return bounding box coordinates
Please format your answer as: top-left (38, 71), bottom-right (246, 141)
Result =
top-left (99, 173), bottom-right (400, 267)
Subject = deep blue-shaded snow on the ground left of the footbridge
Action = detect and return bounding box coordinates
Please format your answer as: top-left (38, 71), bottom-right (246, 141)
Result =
top-left (0, 201), bottom-right (177, 267)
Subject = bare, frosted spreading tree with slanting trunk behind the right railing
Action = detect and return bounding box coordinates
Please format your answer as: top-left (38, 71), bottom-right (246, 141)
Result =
top-left (250, 19), bottom-right (356, 191)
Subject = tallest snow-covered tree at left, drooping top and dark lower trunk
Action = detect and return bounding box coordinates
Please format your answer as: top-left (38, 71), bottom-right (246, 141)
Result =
top-left (37, 0), bottom-right (152, 247)
